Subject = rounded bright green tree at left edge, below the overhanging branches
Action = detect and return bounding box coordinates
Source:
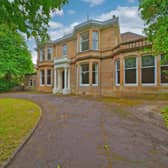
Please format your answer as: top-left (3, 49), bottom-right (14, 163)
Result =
top-left (0, 24), bottom-right (33, 91)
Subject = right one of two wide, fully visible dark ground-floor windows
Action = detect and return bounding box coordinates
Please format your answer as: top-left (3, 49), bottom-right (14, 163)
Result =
top-left (141, 55), bottom-right (155, 84)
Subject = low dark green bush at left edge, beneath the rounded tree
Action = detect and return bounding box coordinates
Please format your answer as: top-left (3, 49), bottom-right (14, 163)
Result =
top-left (0, 79), bottom-right (17, 93)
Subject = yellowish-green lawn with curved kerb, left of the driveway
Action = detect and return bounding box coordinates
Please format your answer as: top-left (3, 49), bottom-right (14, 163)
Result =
top-left (0, 98), bottom-right (40, 166)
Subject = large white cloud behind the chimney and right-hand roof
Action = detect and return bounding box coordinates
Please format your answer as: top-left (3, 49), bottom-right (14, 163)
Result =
top-left (95, 6), bottom-right (144, 34)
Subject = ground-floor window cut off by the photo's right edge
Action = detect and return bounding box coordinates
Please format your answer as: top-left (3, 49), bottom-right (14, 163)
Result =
top-left (160, 55), bottom-right (168, 84)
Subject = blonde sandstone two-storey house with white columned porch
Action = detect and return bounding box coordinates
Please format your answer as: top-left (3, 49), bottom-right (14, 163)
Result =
top-left (37, 17), bottom-right (168, 96)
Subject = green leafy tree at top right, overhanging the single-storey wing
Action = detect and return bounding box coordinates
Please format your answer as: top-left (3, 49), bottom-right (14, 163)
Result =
top-left (139, 0), bottom-right (168, 60)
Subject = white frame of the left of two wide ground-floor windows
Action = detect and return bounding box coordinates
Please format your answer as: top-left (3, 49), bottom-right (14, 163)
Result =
top-left (123, 56), bottom-right (138, 86)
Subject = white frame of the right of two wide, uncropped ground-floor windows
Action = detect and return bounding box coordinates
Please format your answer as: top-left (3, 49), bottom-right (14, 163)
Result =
top-left (141, 55), bottom-right (157, 86)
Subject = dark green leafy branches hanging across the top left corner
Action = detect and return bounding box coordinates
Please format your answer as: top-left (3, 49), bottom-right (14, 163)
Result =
top-left (0, 0), bottom-right (68, 41)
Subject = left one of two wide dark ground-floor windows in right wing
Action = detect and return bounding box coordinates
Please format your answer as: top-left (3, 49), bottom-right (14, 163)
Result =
top-left (125, 57), bottom-right (137, 84)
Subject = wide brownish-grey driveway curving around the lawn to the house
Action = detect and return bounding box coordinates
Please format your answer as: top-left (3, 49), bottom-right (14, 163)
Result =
top-left (1, 93), bottom-right (168, 168)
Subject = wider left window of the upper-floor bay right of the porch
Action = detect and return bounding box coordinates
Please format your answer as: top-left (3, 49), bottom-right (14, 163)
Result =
top-left (80, 32), bottom-right (89, 52)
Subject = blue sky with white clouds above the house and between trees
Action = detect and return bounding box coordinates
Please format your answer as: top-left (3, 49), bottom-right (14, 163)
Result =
top-left (27, 0), bottom-right (144, 64)
